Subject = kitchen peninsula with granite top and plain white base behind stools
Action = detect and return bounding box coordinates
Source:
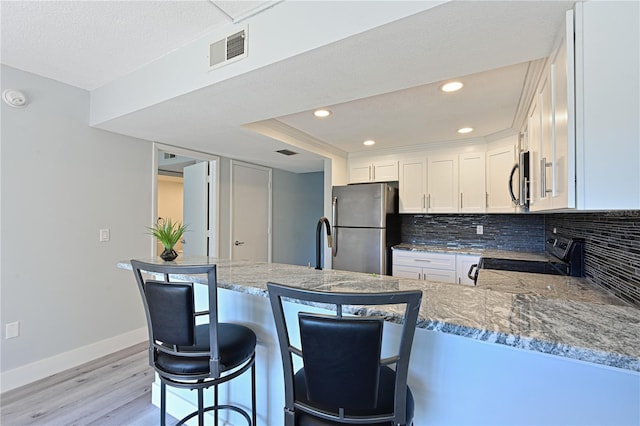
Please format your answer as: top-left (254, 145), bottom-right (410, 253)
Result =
top-left (118, 258), bottom-right (640, 425)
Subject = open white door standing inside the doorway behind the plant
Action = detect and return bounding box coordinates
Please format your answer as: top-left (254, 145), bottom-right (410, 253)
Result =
top-left (183, 161), bottom-right (209, 256)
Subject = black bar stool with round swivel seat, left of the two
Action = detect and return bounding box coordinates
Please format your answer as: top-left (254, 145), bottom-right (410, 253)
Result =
top-left (131, 260), bottom-right (257, 426)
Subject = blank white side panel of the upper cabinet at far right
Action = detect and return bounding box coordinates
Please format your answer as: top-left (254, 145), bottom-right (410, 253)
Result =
top-left (568, 1), bottom-right (640, 210)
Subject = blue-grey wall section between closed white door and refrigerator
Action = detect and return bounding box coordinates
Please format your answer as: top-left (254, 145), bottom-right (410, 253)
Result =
top-left (273, 169), bottom-right (324, 266)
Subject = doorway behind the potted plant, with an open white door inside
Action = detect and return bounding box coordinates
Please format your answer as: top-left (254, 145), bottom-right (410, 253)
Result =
top-left (152, 144), bottom-right (219, 257)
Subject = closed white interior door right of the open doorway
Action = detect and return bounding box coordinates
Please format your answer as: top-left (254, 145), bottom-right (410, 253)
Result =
top-left (230, 161), bottom-right (271, 262)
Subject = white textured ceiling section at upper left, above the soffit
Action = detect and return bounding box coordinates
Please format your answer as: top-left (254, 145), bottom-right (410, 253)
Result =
top-left (0, 0), bottom-right (274, 90)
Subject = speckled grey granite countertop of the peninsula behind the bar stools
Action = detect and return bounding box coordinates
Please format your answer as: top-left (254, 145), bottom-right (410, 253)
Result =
top-left (118, 258), bottom-right (640, 371)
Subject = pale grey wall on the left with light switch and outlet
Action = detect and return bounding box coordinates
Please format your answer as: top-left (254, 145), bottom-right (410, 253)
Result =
top-left (1, 66), bottom-right (152, 391)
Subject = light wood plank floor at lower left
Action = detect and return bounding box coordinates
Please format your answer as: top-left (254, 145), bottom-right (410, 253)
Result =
top-left (0, 343), bottom-right (177, 426)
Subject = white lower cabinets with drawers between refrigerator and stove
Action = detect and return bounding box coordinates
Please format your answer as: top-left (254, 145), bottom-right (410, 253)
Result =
top-left (392, 250), bottom-right (479, 285)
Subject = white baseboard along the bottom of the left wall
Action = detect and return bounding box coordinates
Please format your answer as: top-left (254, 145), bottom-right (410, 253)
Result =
top-left (0, 327), bottom-right (149, 393)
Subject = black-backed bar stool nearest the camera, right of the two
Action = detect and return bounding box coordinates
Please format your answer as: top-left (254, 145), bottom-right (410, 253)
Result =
top-left (267, 283), bottom-right (422, 426)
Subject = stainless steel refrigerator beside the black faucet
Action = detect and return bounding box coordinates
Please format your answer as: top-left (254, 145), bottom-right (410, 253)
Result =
top-left (332, 183), bottom-right (400, 275)
